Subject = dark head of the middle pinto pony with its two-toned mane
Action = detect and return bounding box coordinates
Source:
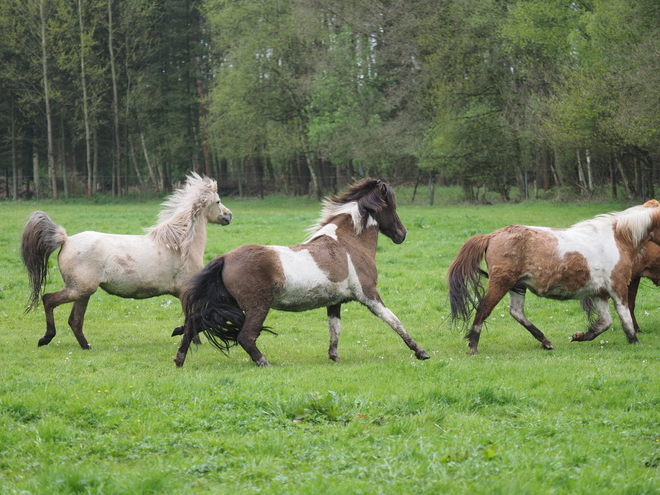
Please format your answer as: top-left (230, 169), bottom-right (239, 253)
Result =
top-left (310, 178), bottom-right (408, 244)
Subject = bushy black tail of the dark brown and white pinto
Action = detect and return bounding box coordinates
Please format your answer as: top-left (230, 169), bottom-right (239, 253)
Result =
top-left (181, 256), bottom-right (245, 354)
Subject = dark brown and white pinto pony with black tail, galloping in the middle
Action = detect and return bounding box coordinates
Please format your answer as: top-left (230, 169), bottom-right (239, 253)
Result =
top-left (174, 179), bottom-right (429, 367)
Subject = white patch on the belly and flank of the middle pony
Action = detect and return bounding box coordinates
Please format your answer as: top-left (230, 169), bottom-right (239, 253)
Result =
top-left (269, 246), bottom-right (359, 311)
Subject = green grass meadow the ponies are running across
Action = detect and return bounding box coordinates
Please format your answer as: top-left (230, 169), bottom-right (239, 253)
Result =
top-left (0, 194), bottom-right (660, 494)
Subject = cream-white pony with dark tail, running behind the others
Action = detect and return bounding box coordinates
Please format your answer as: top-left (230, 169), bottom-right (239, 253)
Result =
top-left (21, 172), bottom-right (232, 349)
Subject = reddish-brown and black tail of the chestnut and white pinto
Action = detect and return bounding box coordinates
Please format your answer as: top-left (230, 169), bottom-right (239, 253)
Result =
top-left (447, 235), bottom-right (490, 322)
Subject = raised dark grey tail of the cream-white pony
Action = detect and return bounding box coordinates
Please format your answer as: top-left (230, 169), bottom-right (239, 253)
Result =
top-left (21, 211), bottom-right (67, 313)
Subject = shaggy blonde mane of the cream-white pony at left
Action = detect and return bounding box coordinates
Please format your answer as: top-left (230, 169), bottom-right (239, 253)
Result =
top-left (145, 172), bottom-right (218, 264)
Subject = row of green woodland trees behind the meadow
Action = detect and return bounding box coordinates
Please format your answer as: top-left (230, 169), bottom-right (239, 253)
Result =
top-left (0, 0), bottom-right (660, 200)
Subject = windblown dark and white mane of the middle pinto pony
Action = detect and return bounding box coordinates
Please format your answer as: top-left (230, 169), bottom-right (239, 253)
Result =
top-left (308, 178), bottom-right (396, 236)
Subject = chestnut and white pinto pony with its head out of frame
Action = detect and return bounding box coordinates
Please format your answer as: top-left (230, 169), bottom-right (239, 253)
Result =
top-left (448, 200), bottom-right (660, 354)
